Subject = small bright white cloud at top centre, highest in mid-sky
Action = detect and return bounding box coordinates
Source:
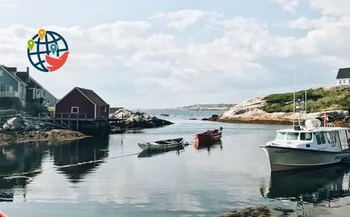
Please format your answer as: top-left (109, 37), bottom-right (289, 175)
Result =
top-left (150, 10), bottom-right (222, 30)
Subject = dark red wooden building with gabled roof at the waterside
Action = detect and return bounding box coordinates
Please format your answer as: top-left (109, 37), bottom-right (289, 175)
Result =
top-left (54, 87), bottom-right (109, 121)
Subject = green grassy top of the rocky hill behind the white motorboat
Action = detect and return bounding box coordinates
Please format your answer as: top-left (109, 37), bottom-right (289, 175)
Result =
top-left (263, 86), bottom-right (350, 113)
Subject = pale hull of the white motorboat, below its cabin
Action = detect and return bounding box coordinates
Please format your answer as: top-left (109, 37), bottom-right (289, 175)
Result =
top-left (261, 146), bottom-right (349, 171)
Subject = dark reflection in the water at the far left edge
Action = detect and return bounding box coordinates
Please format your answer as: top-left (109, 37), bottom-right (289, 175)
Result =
top-left (0, 145), bottom-right (44, 202)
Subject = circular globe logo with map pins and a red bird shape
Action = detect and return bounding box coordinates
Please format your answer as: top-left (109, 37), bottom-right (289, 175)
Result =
top-left (27, 29), bottom-right (69, 72)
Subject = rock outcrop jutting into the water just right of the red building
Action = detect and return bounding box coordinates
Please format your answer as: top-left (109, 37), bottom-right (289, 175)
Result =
top-left (110, 108), bottom-right (173, 128)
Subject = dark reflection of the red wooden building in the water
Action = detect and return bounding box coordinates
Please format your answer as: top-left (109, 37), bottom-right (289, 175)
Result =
top-left (50, 137), bottom-right (108, 183)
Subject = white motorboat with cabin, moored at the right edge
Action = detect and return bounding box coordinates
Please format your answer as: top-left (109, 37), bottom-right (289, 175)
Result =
top-left (260, 119), bottom-right (350, 171)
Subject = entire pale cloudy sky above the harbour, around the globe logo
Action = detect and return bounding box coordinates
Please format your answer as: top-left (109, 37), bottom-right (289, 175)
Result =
top-left (0, 0), bottom-right (350, 109)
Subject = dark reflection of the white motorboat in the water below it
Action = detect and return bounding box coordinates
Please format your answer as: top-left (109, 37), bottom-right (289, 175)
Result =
top-left (260, 165), bottom-right (350, 204)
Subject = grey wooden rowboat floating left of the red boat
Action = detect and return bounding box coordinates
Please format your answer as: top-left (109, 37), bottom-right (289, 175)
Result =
top-left (138, 138), bottom-right (184, 150)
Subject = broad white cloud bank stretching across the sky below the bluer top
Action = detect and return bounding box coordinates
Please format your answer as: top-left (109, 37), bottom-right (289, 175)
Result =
top-left (0, 7), bottom-right (350, 107)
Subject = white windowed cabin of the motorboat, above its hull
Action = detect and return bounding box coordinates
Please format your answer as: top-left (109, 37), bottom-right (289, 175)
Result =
top-left (273, 127), bottom-right (350, 151)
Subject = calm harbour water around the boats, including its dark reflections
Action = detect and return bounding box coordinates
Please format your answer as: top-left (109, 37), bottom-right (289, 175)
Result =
top-left (0, 111), bottom-right (349, 217)
